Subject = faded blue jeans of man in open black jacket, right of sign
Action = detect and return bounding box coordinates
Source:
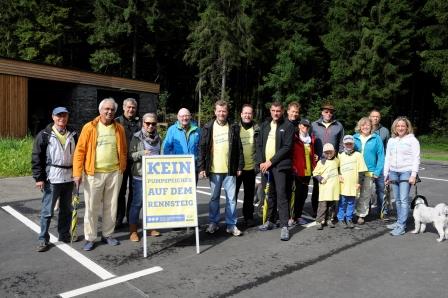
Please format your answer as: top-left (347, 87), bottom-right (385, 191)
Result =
top-left (208, 173), bottom-right (237, 229)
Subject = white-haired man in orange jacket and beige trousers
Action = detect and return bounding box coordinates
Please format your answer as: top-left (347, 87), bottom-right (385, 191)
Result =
top-left (73, 98), bottom-right (127, 251)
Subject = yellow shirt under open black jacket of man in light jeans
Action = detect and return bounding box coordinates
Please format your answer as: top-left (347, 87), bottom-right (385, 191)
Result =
top-left (210, 121), bottom-right (229, 174)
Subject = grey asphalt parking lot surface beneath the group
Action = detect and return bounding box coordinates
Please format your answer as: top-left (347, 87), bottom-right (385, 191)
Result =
top-left (0, 163), bottom-right (448, 298)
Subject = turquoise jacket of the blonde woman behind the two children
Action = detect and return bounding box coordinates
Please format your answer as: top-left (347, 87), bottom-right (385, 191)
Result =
top-left (353, 133), bottom-right (384, 177)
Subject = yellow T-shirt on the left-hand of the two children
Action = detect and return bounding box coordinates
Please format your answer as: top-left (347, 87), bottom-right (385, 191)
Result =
top-left (313, 157), bottom-right (340, 202)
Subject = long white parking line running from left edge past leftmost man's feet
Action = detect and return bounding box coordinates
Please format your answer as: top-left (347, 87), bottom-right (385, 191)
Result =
top-left (2, 206), bottom-right (115, 280)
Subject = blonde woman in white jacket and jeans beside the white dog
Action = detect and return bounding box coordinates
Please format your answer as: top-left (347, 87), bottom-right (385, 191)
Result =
top-left (384, 117), bottom-right (420, 236)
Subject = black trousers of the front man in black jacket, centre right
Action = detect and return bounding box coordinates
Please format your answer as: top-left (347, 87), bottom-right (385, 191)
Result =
top-left (262, 168), bottom-right (291, 227)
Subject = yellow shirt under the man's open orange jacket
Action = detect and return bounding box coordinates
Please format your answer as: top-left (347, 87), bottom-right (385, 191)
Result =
top-left (95, 122), bottom-right (119, 173)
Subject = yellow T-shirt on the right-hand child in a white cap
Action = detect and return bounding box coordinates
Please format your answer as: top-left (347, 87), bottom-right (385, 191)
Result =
top-left (338, 152), bottom-right (367, 197)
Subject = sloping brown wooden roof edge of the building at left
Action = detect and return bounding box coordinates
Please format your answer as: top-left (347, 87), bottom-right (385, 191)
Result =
top-left (0, 58), bottom-right (160, 94)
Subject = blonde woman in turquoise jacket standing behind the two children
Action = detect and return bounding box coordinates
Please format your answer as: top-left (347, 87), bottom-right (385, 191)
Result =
top-left (353, 117), bottom-right (384, 225)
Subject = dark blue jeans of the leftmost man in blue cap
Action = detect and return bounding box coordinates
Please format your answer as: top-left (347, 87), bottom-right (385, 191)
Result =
top-left (39, 181), bottom-right (73, 243)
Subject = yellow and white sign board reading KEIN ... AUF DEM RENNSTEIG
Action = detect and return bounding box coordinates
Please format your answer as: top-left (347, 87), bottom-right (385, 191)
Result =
top-left (142, 155), bottom-right (198, 229)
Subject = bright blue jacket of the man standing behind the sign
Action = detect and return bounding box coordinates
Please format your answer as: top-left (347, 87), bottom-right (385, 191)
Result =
top-left (162, 121), bottom-right (201, 168)
